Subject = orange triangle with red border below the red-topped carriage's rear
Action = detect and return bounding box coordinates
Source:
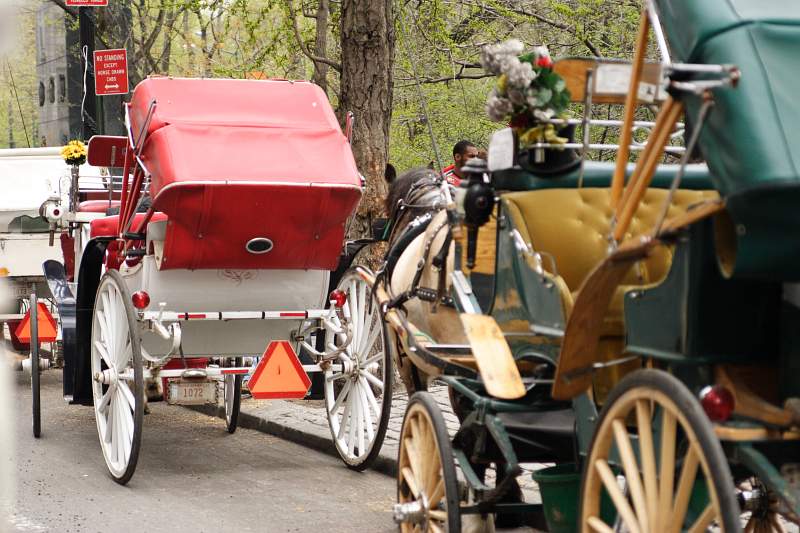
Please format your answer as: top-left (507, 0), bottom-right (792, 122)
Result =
top-left (247, 341), bottom-right (311, 400)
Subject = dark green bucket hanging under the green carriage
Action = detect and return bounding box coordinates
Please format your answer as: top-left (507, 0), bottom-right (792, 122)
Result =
top-left (533, 463), bottom-right (615, 533)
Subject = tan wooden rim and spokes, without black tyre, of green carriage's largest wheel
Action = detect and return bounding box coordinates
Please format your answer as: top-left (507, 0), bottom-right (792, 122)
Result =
top-left (582, 387), bottom-right (724, 533)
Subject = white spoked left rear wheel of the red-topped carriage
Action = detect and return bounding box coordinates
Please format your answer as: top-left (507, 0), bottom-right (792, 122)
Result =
top-left (92, 270), bottom-right (144, 485)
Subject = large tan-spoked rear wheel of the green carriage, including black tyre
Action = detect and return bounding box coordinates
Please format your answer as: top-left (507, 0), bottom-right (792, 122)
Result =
top-left (580, 370), bottom-right (741, 533)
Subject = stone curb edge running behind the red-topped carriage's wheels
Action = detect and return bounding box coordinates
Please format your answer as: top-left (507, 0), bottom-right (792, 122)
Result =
top-left (184, 405), bottom-right (397, 477)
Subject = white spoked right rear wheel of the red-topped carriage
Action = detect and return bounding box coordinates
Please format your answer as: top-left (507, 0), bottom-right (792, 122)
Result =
top-left (325, 270), bottom-right (393, 470)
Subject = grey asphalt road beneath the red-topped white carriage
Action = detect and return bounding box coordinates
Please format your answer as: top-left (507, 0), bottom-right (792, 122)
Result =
top-left (6, 371), bottom-right (396, 533)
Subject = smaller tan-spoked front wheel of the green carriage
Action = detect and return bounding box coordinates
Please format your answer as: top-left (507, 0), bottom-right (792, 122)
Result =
top-left (395, 392), bottom-right (461, 533)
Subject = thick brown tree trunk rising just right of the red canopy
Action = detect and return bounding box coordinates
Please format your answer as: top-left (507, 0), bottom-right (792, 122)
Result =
top-left (339, 0), bottom-right (395, 245)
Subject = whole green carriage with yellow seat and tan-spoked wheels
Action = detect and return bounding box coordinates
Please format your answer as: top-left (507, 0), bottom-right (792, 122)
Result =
top-left (361, 0), bottom-right (800, 532)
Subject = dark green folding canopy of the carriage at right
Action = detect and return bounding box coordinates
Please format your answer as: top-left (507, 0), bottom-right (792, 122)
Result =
top-left (656, 0), bottom-right (800, 280)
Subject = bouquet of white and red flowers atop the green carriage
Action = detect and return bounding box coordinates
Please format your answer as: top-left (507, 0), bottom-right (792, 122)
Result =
top-left (481, 39), bottom-right (570, 148)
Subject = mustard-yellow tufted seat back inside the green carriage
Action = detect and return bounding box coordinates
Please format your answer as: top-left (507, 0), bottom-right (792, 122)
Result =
top-left (503, 188), bottom-right (718, 293)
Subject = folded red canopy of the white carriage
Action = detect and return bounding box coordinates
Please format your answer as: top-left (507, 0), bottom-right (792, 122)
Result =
top-left (130, 78), bottom-right (361, 270)
